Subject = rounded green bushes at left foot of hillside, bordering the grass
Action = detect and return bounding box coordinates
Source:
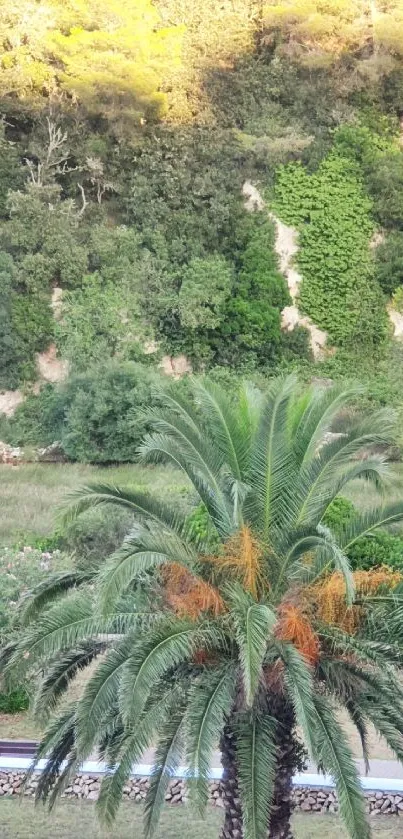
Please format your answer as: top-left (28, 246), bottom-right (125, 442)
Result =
top-left (1, 361), bottom-right (165, 463)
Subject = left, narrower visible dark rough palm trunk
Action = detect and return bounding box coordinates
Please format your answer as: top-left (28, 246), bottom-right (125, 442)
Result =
top-left (220, 726), bottom-right (243, 839)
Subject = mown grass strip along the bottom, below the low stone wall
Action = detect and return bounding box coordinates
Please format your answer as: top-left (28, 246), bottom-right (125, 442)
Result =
top-left (0, 799), bottom-right (403, 839)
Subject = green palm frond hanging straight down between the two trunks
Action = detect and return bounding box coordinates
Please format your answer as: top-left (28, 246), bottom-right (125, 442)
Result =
top-left (237, 715), bottom-right (277, 839)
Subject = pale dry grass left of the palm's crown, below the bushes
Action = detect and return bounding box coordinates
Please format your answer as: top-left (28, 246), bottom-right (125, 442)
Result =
top-left (0, 463), bottom-right (188, 545)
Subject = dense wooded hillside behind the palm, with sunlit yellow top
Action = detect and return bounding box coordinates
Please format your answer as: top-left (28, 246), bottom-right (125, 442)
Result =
top-left (0, 0), bottom-right (403, 462)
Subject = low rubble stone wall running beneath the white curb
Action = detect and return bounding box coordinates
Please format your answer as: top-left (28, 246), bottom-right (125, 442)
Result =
top-left (0, 770), bottom-right (403, 816)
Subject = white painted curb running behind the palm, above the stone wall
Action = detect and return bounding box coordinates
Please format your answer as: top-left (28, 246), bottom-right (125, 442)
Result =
top-left (0, 755), bottom-right (403, 793)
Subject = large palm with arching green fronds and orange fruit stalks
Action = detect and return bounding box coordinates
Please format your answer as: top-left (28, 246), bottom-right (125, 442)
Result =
top-left (4, 377), bottom-right (403, 839)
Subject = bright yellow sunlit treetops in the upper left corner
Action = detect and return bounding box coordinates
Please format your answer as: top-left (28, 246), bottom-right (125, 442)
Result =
top-left (0, 0), bottom-right (183, 130)
